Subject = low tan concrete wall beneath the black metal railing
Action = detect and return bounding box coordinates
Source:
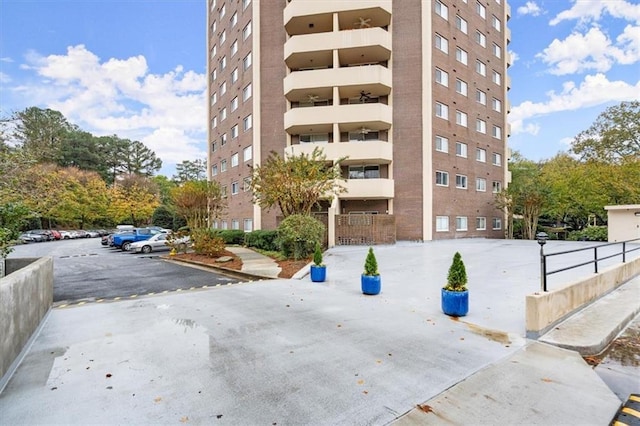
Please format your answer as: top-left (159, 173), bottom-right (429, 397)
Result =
top-left (526, 258), bottom-right (640, 339)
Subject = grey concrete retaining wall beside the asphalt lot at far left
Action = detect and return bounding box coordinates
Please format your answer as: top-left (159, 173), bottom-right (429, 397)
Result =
top-left (0, 257), bottom-right (53, 382)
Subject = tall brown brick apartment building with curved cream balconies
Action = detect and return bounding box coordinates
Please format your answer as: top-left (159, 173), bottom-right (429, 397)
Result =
top-left (207, 0), bottom-right (510, 245)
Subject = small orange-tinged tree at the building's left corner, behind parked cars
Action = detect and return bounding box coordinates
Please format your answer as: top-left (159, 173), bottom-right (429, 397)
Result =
top-left (171, 180), bottom-right (225, 230)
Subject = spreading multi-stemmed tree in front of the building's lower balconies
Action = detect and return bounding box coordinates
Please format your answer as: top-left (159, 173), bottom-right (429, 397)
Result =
top-left (251, 148), bottom-right (346, 217)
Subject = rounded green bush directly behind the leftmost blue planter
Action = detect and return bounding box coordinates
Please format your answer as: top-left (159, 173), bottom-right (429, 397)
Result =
top-left (276, 214), bottom-right (324, 260)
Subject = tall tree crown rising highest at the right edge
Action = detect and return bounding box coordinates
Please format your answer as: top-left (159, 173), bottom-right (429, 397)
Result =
top-left (571, 101), bottom-right (640, 164)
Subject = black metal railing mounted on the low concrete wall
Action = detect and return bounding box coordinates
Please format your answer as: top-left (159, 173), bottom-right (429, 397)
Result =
top-left (537, 234), bottom-right (640, 291)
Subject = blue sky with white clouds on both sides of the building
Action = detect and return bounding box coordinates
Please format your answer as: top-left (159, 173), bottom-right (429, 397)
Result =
top-left (0, 0), bottom-right (640, 176)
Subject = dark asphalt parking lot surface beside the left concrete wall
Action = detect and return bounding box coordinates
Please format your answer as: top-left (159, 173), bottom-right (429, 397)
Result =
top-left (9, 238), bottom-right (238, 303)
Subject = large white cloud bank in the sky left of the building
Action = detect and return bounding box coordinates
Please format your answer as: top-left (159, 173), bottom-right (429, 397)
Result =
top-left (14, 45), bottom-right (207, 173)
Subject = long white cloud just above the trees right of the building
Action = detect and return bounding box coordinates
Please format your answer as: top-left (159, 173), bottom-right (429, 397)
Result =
top-left (509, 74), bottom-right (640, 135)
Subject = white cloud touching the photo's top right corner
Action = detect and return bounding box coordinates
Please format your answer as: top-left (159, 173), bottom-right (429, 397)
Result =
top-left (549, 0), bottom-right (640, 25)
